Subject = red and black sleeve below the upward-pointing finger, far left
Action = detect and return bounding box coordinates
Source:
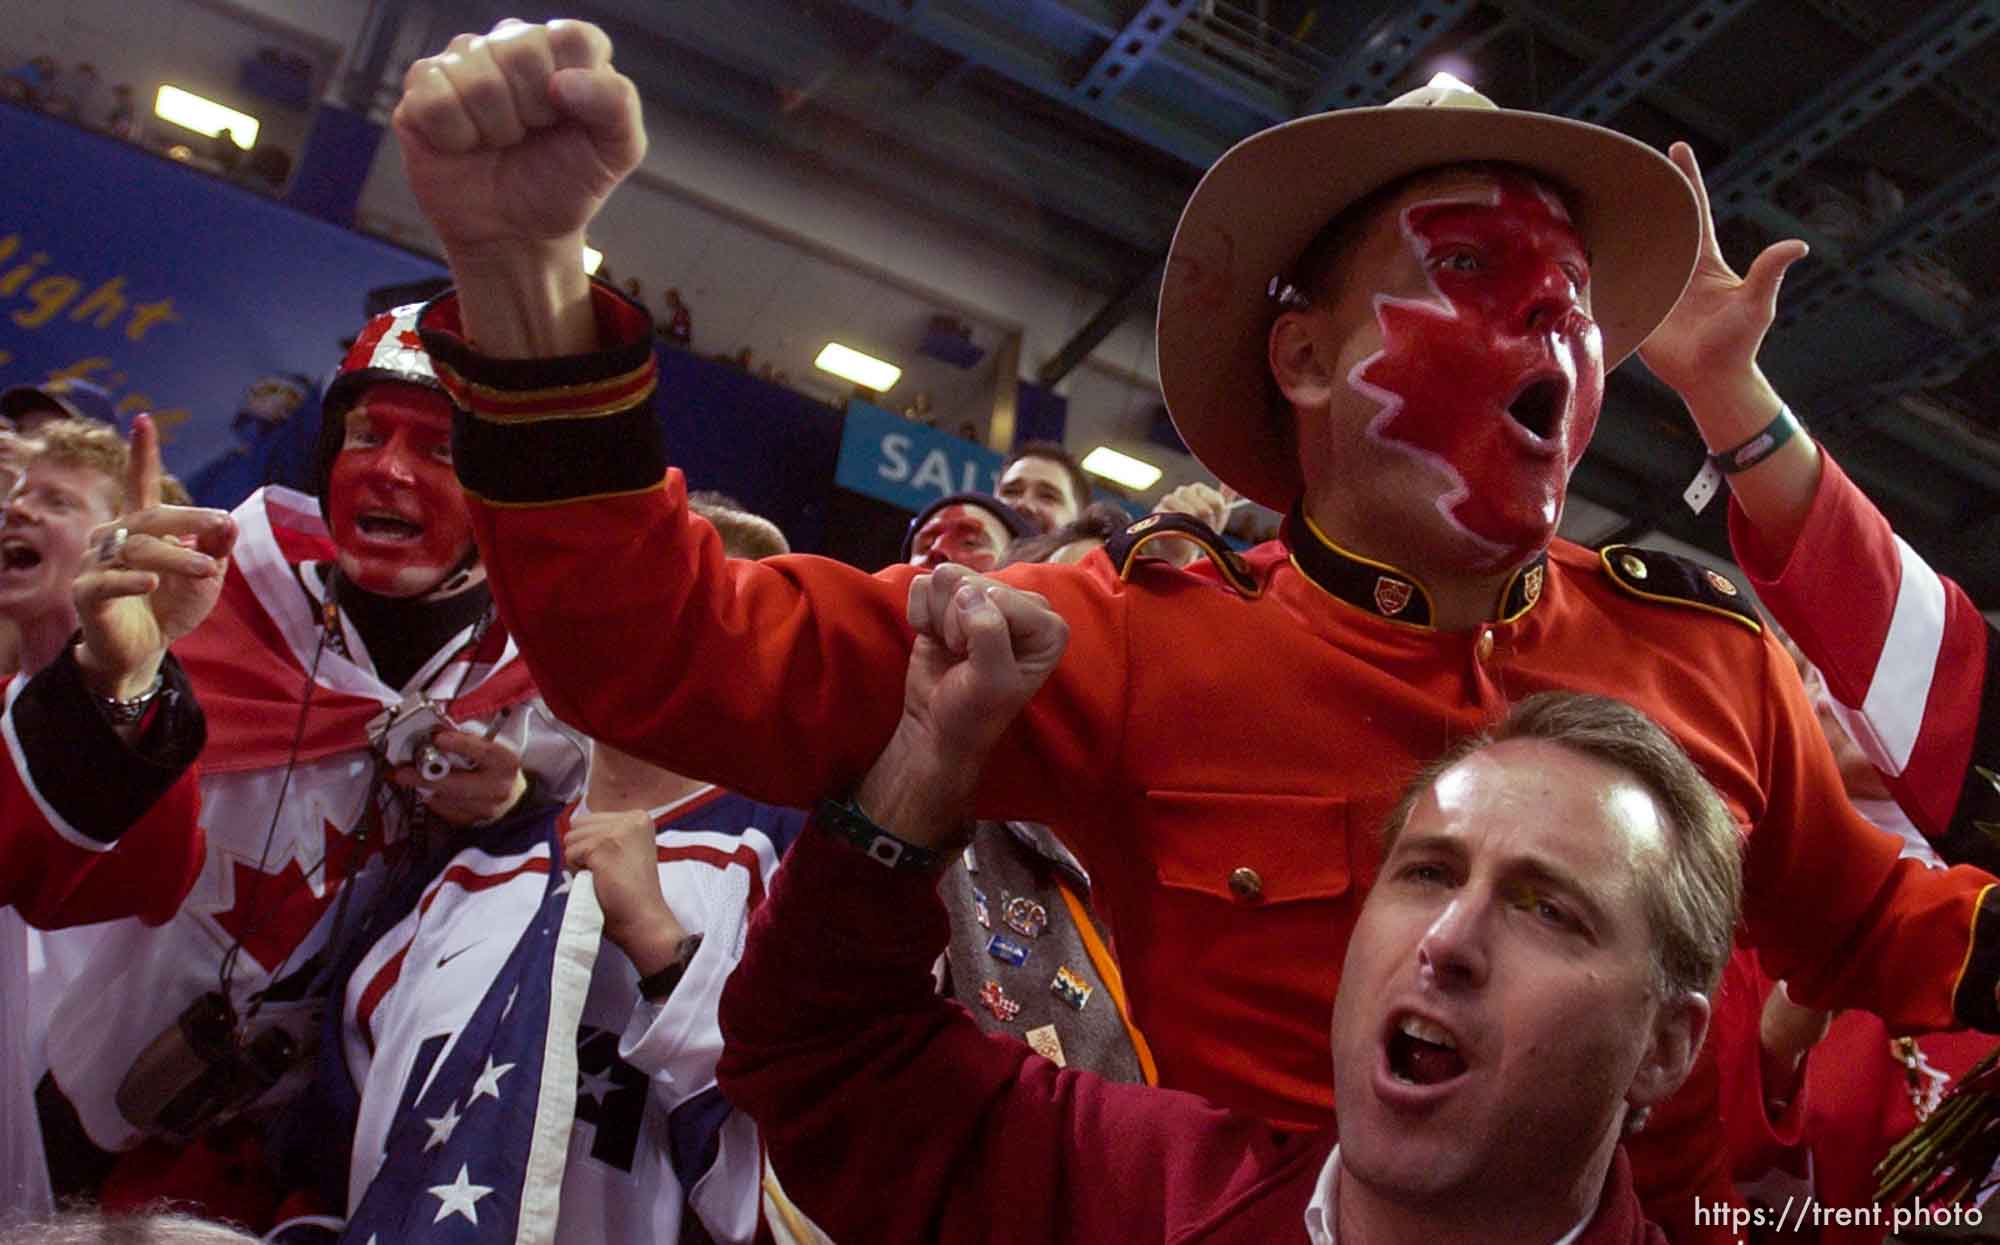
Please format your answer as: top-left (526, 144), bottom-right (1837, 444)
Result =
top-left (0, 651), bottom-right (204, 929)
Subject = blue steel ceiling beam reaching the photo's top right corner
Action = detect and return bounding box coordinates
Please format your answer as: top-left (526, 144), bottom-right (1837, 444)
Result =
top-left (1708, 0), bottom-right (2000, 218)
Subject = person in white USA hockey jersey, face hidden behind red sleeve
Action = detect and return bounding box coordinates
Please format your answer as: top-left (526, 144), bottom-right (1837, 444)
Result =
top-left (320, 502), bottom-right (804, 1245)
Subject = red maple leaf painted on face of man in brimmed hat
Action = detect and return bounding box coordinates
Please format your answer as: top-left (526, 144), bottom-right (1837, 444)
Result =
top-left (1348, 172), bottom-right (1604, 562)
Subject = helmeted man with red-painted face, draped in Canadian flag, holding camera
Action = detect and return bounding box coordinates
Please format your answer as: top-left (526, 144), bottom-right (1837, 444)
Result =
top-left (40, 306), bottom-right (584, 1217)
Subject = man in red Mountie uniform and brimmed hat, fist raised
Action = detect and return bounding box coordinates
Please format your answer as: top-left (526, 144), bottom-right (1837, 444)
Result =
top-left (396, 22), bottom-right (2000, 1235)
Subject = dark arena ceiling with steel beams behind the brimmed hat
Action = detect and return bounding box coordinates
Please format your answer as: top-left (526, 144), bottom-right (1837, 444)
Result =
top-left (410, 0), bottom-right (2000, 610)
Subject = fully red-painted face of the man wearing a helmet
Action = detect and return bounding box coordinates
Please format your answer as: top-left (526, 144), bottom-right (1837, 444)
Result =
top-left (326, 384), bottom-right (472, 596)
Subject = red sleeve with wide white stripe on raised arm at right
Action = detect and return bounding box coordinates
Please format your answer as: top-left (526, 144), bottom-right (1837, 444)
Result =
top-left (1730, 456), bottom-right (2000, 852)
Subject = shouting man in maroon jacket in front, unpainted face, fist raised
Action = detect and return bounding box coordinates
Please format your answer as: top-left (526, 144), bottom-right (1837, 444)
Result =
top-left (722, 568), bottom-right (1740, 1245)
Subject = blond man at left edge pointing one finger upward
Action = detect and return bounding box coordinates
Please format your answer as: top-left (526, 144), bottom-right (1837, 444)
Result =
top-left (0, 418), bottom-right (236, 1227)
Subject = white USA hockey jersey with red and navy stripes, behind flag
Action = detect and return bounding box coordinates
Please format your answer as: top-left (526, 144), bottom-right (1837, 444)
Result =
top-left (340, 787), bottom-right (804, 1243)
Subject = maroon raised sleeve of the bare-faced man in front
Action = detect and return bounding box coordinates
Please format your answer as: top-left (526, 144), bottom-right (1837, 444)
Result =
top-left (716, 827), bottom-right (1300, 1243)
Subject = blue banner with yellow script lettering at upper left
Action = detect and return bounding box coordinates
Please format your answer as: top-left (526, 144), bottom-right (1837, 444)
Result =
top-left (0, 106), bottom-right (442, 474)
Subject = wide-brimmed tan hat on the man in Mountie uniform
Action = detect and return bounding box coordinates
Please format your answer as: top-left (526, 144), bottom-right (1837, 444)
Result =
top-left (1160, 86), bottom-right (1702, 510)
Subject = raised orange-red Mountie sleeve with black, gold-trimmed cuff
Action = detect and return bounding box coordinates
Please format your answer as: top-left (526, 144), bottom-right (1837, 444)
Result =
top-left (422, 286), bottom-right (1126, 844)
